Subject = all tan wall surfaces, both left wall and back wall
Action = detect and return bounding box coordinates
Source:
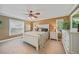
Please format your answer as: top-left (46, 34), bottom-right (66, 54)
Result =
top-left (0, 15), bottom-right (69, 40)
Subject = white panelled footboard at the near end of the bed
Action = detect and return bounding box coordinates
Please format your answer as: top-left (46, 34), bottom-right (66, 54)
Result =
top-left (23, 35), bottom-right (39, 50)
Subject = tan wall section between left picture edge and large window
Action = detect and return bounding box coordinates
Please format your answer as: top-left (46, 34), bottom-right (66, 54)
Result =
top-left (0, 16), bottom-right (9, 39)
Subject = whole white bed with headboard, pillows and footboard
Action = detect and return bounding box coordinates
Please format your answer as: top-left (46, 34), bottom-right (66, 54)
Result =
top-left (23, 24), bottom-right (49, 50)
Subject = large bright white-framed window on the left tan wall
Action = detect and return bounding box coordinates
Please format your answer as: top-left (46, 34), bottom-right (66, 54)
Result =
top-left (9, 18), bottom-right (24, 35)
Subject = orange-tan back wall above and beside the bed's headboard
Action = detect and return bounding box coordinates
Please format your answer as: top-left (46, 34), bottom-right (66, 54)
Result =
top-left (33, 16), bottom-right (70, 32)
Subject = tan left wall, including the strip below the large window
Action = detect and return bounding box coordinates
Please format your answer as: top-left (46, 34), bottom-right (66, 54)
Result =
top-left (0, 15), bottom-right (22, 40)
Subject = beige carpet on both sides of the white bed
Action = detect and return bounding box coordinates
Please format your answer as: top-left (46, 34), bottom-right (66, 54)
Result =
top-left (0, 39), bottom-right (65, 54)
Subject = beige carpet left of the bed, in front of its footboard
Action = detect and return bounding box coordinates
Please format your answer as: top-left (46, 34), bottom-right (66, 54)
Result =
top-left (0, 39), bottom-right (37, 54)
